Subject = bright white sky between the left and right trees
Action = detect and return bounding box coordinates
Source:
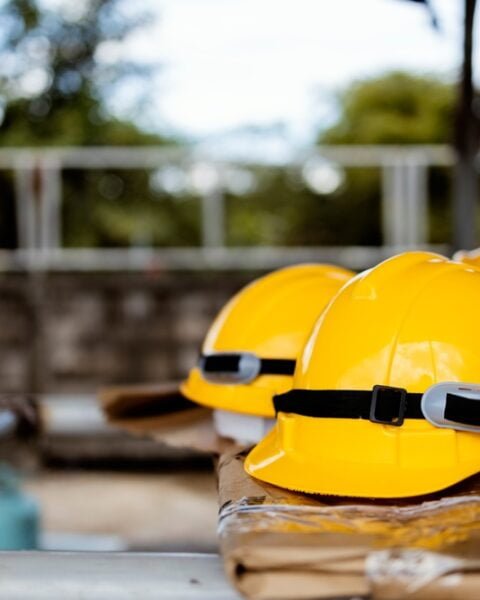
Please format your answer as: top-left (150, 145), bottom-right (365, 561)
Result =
top-left (110, 0), bottom-right (463, 149)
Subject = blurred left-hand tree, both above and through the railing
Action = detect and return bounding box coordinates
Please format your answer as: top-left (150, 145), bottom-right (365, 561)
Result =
top-left (0, 0), bottom-right (199, 247)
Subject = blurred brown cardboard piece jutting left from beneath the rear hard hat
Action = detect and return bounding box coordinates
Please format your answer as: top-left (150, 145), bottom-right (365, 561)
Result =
top-left (98, 382), bottom-right (236, 454)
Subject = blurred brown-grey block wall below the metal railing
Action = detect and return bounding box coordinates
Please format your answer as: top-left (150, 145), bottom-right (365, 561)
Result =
top-left (0, 273), bottom-right (251, 393)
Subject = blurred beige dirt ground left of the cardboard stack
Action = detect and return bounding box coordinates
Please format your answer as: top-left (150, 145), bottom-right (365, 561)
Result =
top-left (24, 470), bottom-right (217, 552)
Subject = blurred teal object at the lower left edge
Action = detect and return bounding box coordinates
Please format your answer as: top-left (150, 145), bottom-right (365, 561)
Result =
top-left (0, 465), bottom-right (40, 550)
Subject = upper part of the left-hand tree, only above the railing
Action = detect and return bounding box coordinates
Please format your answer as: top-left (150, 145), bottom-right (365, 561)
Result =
top-left (0, 0), bottom-right (160, 146)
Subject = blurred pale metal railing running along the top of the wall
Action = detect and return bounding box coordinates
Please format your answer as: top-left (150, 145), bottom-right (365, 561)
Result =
top-left (0, 145), bottom-right (455, 271)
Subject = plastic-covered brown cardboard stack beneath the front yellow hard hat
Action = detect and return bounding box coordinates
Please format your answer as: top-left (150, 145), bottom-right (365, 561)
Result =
top-left (218, 451), bottom-right (480, 600)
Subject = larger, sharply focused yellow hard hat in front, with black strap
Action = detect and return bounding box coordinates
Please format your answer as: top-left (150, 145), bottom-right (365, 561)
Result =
top-left (245, 252), bottom-right (480, 498)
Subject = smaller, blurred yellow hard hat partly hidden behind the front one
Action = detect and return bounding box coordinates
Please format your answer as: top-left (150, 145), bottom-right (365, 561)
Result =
top-left (181, 264), bottom-right (353, 417)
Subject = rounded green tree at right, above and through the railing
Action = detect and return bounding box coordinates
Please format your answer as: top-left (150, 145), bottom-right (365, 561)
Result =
top-left (284, 72), bottom-right (455, 245)
